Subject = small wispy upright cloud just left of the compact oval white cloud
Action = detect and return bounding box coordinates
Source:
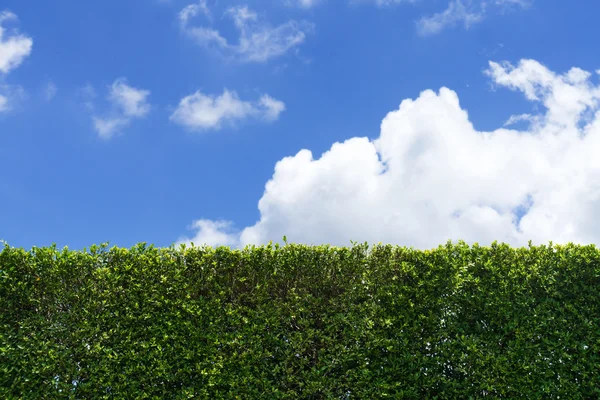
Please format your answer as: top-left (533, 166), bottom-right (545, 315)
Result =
top-left (93, 78), bottom-right (150, 139)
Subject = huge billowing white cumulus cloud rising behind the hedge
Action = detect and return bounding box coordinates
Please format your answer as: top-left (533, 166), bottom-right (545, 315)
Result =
top-left (180, 60), bottom-right (600, 248)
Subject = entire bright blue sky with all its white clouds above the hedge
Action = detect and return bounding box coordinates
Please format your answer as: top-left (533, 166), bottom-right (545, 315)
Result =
top-left (0, 0), bottom-right (600, 249)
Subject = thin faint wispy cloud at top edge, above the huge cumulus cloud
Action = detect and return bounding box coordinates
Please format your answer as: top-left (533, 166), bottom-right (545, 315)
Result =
top-left (417, 0), bottom-right (533, 36)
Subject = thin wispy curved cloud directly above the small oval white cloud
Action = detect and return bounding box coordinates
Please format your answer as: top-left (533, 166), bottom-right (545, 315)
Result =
top-left (179, 1), bottom-right (314, 62)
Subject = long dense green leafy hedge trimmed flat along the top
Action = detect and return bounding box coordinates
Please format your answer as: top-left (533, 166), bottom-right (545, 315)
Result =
top-left (0, 241), bottom-right (600, 399)
